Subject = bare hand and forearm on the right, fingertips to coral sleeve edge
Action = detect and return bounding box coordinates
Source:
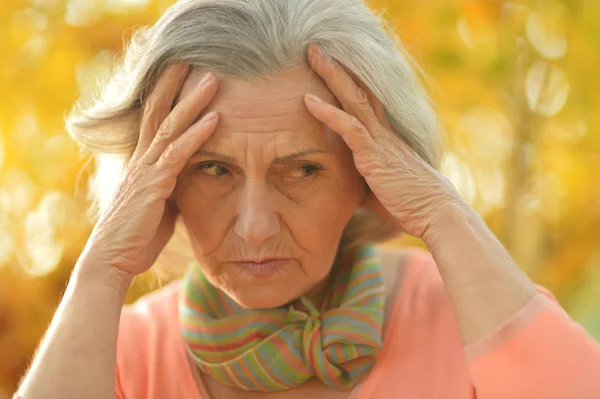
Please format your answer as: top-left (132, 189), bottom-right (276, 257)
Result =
top-left (305, 44), bottom-right (536, 345)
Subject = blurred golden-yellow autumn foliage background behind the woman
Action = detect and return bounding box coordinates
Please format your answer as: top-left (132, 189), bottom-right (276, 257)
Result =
top-left (0, 0), bottom-right (600, 399)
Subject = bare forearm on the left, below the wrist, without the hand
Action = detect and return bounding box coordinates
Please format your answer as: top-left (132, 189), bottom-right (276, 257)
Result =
top-left (17, 256), bottom-right (132, 399)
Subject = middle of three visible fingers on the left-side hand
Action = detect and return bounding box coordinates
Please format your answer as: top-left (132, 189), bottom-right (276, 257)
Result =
top-left (142, 72), bottom-right (217, 165)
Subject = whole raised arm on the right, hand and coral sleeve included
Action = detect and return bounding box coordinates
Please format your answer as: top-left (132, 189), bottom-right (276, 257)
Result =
top-left (305, 45), bottom-right (600, 399)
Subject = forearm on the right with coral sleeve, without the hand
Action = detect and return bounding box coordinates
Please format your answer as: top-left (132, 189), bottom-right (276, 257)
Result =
top-left (423, 204), bottom-right (600, 399)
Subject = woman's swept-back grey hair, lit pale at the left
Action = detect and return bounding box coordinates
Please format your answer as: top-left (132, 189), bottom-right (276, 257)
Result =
top-left (66, 0), bottom-right (441, 277)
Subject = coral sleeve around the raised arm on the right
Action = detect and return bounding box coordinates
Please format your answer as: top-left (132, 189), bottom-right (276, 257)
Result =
top-left (465, 286), bottom-right (600, 399)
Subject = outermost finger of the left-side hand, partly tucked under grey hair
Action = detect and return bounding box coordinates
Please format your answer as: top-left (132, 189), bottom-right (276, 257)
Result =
top-left (134, 64), bottom-right (189, 158)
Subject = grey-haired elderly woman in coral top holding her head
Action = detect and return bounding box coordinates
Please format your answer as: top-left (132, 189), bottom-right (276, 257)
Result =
top-left (17, 0), bottom-right (600, 399)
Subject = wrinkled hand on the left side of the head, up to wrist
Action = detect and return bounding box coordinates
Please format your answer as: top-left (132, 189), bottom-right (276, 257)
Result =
top-left (84, 64), bottom-right (219, 277)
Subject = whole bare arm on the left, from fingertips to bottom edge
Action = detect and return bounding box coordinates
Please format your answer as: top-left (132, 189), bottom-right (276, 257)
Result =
top-left (17, 64), bottom-right (219, 399)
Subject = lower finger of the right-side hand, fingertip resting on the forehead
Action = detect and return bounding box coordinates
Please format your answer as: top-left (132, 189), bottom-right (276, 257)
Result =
top-left (304, 94), bottom-right (373, 154)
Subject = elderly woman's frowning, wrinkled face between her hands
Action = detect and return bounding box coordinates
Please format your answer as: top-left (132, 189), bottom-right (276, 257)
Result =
top-left (173, 65), bottom-right (365, 308)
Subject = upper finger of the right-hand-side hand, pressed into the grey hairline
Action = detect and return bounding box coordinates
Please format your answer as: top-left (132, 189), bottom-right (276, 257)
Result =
top-left (307, 44), bottom-right (379, 134)
